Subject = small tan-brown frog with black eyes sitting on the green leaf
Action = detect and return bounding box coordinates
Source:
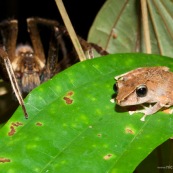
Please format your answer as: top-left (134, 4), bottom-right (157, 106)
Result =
top-left (114, 66), bottom-right (173, 121)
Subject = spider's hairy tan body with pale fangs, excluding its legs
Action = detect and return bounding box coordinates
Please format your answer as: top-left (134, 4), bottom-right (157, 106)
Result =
top-left (11, 45), bottom-right (45, 93)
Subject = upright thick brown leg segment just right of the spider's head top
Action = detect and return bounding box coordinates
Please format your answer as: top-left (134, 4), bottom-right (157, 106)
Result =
top-left (27, 18), bottom-right (46, 64)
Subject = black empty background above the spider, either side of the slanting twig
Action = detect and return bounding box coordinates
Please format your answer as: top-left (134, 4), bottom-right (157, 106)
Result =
top-left (0, 0), bottom-right (106, 41)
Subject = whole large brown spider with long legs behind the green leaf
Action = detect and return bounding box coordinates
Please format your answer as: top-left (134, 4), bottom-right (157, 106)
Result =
top-left (0, 18), bottom-right (107, 118)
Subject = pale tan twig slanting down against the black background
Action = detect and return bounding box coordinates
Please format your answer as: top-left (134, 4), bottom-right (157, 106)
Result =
top-left (55, 0), bottom-right (86, 61)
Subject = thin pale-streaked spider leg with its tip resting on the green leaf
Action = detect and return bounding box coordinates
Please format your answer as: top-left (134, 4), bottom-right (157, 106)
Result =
top-left (0, 47), bottom-right (28, 118)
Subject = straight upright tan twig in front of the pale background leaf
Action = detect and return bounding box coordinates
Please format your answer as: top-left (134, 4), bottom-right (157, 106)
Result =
top-left (141, 0), bottom-right (151, 53)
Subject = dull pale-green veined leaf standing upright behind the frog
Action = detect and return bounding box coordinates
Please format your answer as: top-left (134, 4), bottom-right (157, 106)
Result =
top-left (88, 0), bottom-right (173, 57)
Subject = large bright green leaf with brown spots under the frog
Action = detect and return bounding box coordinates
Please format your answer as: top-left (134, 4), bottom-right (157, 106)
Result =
top-left (0, 54), bottom-right (173, 173)
